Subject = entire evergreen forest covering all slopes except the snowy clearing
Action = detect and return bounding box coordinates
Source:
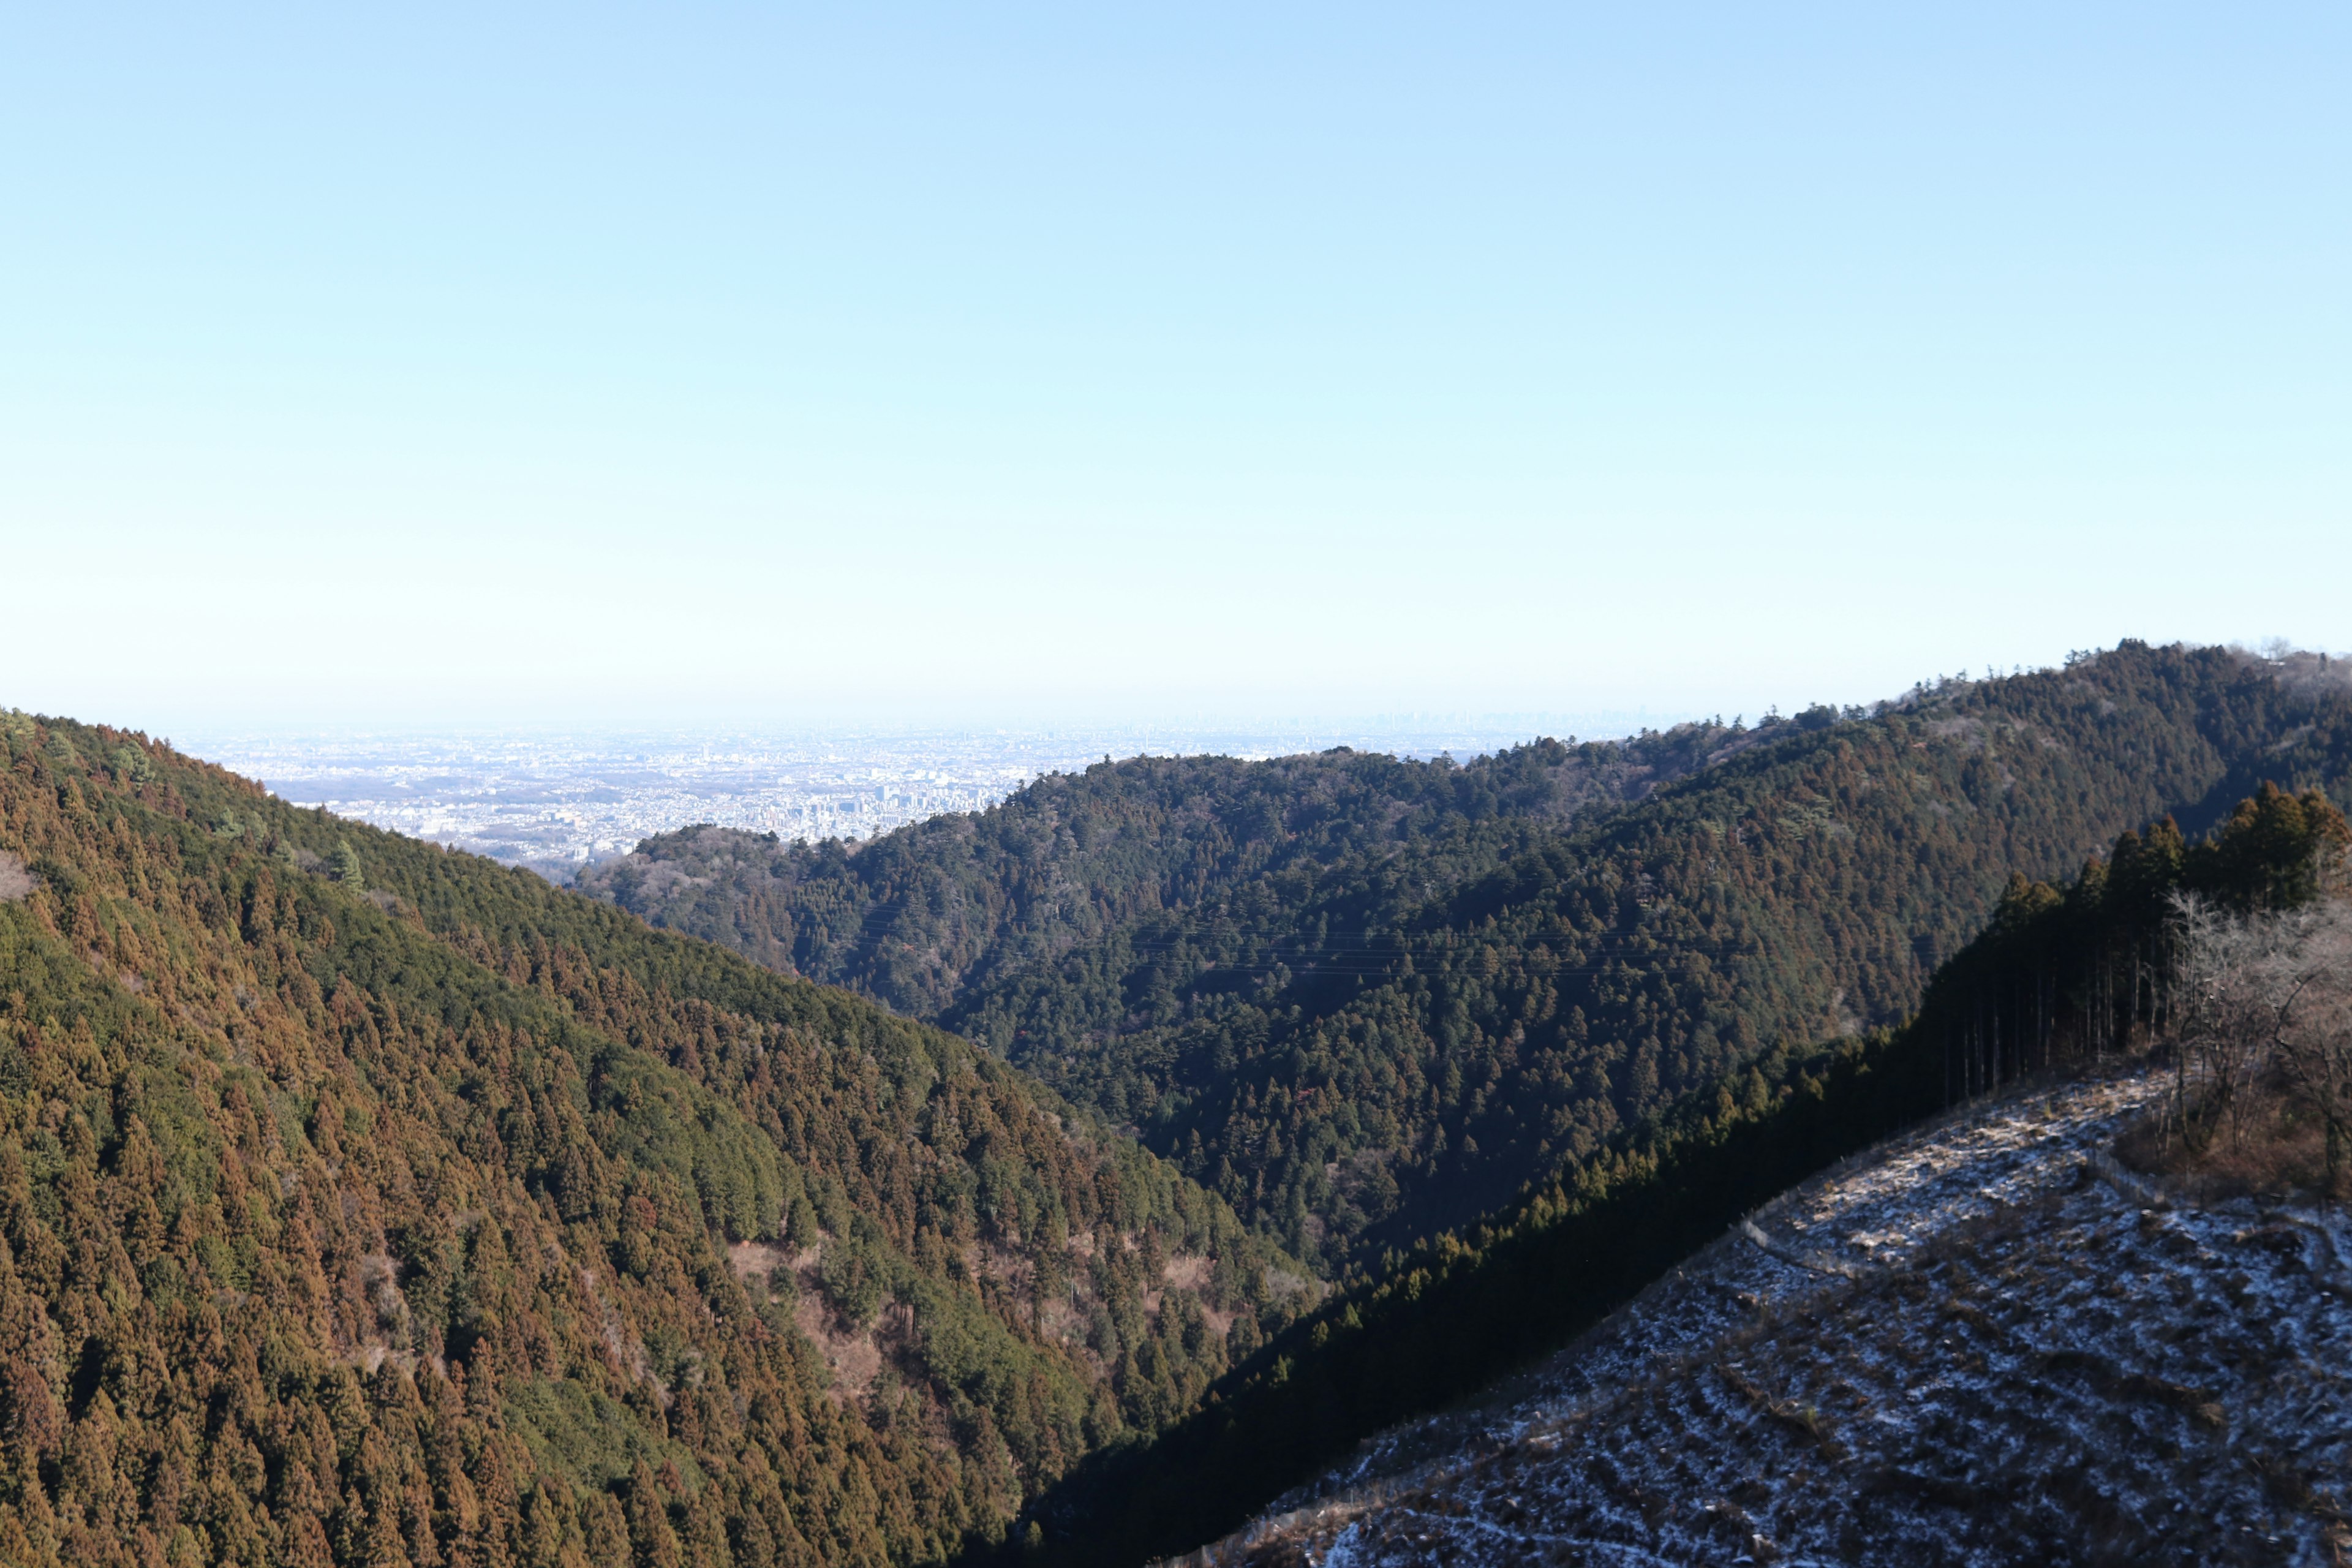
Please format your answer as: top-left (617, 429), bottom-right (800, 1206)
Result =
top-left (13, 644), bottom-right (2352, 1568)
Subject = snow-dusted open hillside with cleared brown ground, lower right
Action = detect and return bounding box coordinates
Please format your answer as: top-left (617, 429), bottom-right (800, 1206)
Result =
top-left (1178, 1077), bottom-right (2352, 1568)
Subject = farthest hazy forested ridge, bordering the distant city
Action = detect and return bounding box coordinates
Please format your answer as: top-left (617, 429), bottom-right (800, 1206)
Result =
top-left (576, 726), bottom-right (1728, 1018)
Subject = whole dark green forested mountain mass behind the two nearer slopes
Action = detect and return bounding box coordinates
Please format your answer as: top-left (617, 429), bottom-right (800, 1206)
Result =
top-left (581, 642), bottom-right (2352, 1272)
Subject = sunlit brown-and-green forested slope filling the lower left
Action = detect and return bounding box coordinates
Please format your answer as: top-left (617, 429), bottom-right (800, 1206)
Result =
top-left (0, 712), bottom-right (1303, 1568)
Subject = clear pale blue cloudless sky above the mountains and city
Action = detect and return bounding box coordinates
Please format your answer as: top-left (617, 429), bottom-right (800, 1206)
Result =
top-left (0, 5), bottom-right (2352, 731)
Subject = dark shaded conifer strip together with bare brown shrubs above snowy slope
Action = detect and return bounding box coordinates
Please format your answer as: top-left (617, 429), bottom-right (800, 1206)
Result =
top-left (1016, 785), bottom-right (2352, 1563)
